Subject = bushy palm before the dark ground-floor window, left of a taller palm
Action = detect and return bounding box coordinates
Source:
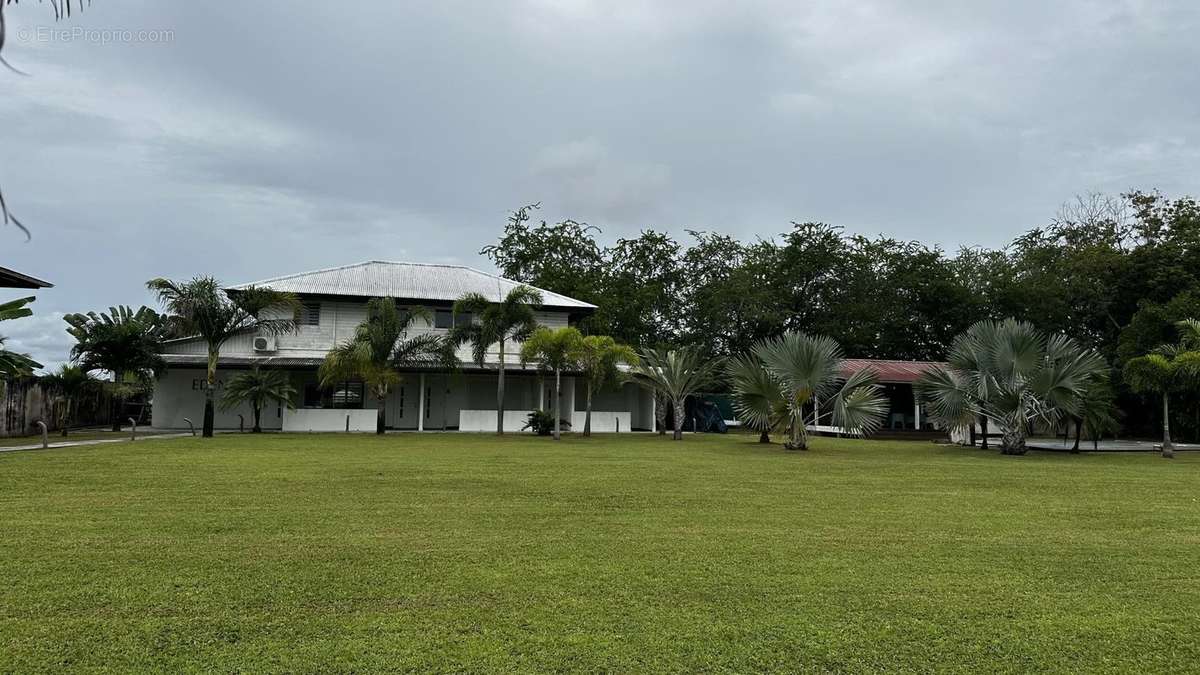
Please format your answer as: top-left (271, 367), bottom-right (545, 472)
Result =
top-left (320, 298), bottom-right (454, 434)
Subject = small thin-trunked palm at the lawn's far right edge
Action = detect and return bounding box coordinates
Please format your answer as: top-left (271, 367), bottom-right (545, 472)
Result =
top-left (1122, 319), bottom-right (1200, 459)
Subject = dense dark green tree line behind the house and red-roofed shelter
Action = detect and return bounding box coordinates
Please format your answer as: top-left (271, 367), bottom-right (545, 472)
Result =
top-left (482, 192), bottom-right (1200, 438)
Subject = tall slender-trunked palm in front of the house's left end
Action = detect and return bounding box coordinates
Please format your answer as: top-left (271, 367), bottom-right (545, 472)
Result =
top-left (146, 276), bottom-right (300, 438)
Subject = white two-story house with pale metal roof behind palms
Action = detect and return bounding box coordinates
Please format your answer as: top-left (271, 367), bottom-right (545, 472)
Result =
top-left (152, 261), bottom-right (654, 431)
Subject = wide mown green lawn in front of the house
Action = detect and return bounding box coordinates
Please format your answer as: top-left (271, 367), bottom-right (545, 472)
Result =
top-left (0, 435), bottom-right (1200, 673)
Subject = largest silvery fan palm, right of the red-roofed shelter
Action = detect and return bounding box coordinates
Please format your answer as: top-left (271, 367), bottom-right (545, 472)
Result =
top-left (917, 318), bottom-right (1108, 455)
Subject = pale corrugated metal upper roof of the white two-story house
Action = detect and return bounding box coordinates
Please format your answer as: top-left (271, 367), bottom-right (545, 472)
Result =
top-left (230, 261), bottom-right (595, 310)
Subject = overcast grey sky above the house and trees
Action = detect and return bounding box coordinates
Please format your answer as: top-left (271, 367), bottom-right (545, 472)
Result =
top-left (7, 0), bottom-right (1200, 364)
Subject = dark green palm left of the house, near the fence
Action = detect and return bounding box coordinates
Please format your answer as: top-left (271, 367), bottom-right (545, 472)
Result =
top-left (62, 305), bottom-right (167, 431)
